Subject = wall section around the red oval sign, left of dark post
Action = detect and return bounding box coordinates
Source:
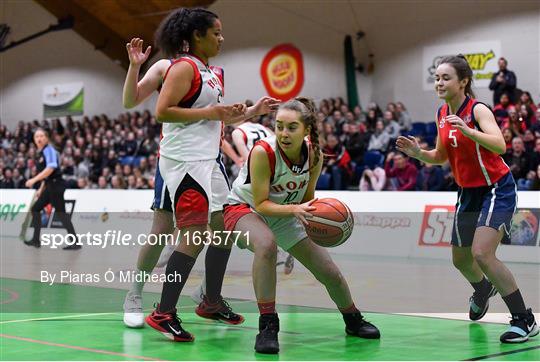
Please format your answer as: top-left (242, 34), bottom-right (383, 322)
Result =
top-left (210, 1), bottom-right (370, 107)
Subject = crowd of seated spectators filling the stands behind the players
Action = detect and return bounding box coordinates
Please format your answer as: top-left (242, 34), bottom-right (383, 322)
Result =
top-left (0, 92), bottom-right (540, 191)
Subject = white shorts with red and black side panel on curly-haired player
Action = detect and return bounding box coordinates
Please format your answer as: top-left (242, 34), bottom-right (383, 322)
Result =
top-left (159, 155), bottom-right (230, 229)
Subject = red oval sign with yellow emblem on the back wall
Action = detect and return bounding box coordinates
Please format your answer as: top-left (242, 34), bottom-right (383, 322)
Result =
top-left (261, 44), bottom-right (304, 101)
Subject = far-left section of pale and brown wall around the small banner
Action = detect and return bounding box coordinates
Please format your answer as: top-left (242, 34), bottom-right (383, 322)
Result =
top-left (0, 0), bottom-right (155, 128)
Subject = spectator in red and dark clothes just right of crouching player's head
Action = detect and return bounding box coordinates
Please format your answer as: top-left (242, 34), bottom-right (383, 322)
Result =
top-left (321, 134), bottom-right (352, 190)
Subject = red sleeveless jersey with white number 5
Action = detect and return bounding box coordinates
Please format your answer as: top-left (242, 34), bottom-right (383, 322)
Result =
top-left (437, 97), bottom-right (510, 187)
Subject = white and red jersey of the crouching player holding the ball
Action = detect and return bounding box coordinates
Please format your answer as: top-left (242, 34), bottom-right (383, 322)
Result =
top-left (228, 136), bottom-right (310, 208)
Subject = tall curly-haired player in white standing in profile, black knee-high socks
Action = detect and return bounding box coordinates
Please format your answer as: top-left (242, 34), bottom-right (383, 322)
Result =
top-left (146, 8), bottom-right (277, 342)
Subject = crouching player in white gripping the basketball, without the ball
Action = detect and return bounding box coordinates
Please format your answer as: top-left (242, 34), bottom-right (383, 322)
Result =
top-left (224, 98), bottom-right (380, 353)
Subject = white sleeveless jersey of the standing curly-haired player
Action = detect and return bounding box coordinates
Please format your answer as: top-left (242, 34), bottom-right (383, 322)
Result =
top-left (159, 55), bottom-right (223, 161)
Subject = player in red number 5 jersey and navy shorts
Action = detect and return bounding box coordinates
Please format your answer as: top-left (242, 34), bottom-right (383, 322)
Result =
top-left (397, 55), bottom-right (539, 343)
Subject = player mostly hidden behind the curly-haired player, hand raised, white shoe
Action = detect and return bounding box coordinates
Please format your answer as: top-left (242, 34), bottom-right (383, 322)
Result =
top-left (123, 38), bottom-right (240, 328)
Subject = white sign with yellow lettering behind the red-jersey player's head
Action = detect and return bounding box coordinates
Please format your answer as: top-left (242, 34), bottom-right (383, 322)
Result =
top-left (422, 41), bottom-right (502, 90)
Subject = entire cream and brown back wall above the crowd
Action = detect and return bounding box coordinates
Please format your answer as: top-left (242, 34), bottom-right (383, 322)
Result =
top-left (0, 0), bottom-right (540, 125)
